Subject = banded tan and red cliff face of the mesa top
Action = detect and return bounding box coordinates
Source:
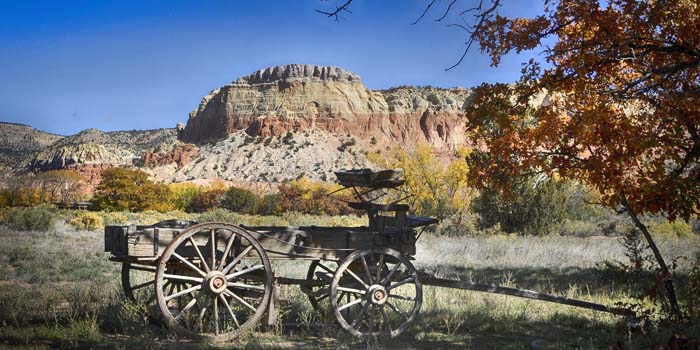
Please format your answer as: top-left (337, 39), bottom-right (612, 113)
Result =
top-left (181, 64), bottom-right (470, 151)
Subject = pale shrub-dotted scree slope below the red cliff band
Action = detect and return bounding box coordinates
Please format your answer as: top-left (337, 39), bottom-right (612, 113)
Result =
top-left (150, 129), bottom-right (372, 183)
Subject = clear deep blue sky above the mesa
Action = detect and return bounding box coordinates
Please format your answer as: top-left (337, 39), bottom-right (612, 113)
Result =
top-left (0, 0), bottom-right (542, 135)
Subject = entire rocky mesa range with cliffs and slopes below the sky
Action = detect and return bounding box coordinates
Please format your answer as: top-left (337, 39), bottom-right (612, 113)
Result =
top-left (0, 64), bottom-right (541, 184)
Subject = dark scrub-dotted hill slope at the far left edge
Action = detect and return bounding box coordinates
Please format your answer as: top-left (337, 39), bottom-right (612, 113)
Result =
top-left (0, 122), bottom-right (63, 174)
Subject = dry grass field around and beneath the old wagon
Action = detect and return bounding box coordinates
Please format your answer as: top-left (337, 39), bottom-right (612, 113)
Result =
top-left (0, 219), bottom-right (699, 349)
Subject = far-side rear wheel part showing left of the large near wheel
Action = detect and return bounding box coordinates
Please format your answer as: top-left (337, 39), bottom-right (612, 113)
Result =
top-left (121, 262), bottom-right (158, 319)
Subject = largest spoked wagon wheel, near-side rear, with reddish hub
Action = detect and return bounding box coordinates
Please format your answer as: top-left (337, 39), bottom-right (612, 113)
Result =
top-left (156, 223), bottom-right (273, 341)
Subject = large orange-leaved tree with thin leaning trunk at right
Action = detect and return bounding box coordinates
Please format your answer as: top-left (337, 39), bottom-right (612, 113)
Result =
top-left (320, 0), bottom-right (700, 315)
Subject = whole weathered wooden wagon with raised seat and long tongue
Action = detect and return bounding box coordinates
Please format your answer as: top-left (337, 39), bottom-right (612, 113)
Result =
top-left (105, 169), bottom-right (627, 341)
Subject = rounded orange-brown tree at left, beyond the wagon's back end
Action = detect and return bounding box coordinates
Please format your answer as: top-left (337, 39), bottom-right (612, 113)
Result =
top-left (93, 168), bottom-right (172, 211)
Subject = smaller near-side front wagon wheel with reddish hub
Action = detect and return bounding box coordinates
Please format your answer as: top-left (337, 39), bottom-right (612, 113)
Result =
top-left (330, 248), bottom-right (423, 338)
